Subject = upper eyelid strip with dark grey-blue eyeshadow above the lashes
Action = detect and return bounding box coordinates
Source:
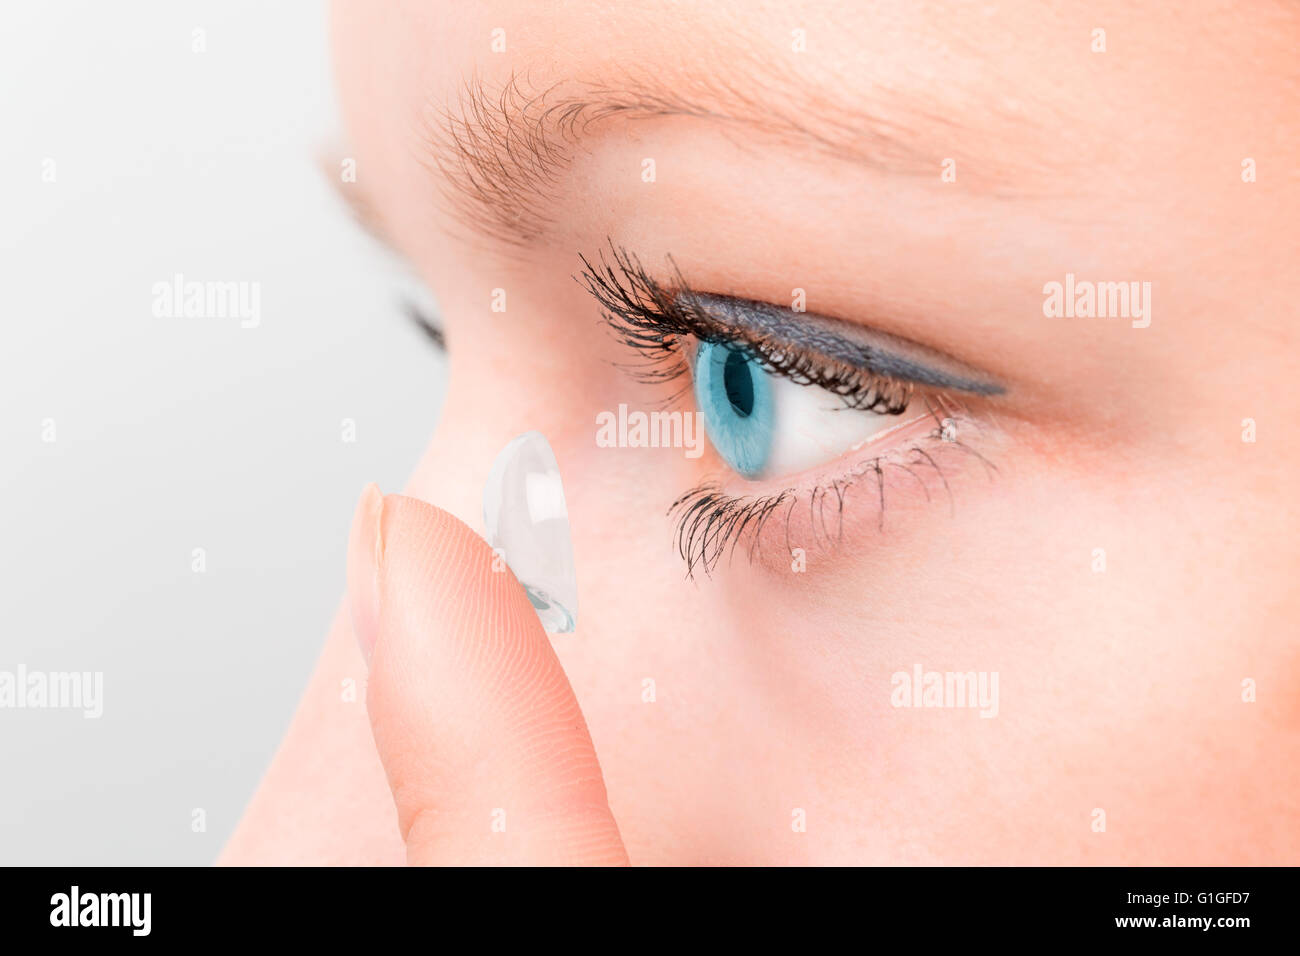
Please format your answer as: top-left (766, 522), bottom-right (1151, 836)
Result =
top-left (676, 291), bottom-right (1006, 395)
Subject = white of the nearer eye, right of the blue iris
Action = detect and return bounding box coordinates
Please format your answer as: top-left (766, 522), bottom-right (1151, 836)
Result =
top-left (758, 372), bottom-right (915, 479)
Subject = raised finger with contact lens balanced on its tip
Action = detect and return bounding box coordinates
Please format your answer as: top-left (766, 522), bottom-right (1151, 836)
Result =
top-left (358, 496), bottom-right (627, 862)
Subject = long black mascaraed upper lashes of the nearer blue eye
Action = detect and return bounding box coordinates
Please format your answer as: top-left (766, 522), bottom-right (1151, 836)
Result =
top-left (577, 241), bottom-right (913, 415)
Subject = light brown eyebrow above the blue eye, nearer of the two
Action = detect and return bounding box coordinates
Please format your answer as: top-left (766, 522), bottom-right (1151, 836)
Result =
top-left (421, 71), bottom-right (1040, 246)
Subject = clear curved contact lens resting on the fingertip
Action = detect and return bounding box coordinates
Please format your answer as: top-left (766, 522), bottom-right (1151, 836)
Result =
top-left (484, 432), bottom-right (577, 633)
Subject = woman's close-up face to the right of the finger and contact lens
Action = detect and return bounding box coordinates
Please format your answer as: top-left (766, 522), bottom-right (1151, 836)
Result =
top-left (317, 0), bottom-right (1300, 864)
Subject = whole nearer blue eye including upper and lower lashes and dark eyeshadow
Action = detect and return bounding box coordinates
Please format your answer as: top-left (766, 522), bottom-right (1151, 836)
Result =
top-left (577, 242), bottom-right (1005, 575)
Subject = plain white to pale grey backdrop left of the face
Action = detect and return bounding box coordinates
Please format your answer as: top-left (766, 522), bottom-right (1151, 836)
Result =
top-left (0, 0), bottom-right (445, 864)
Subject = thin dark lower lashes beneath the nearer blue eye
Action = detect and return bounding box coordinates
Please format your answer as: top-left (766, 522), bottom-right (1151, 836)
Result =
top-left (668, 406), bottom-right (997, 578)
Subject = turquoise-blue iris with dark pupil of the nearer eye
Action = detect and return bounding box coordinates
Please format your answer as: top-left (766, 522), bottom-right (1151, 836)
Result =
top-left (696, 342), bottom-right (775, 477)
